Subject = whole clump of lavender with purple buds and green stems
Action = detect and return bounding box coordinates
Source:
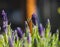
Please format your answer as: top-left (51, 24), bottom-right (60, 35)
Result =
top-left (0, 10), bottom-right (60, 47)
